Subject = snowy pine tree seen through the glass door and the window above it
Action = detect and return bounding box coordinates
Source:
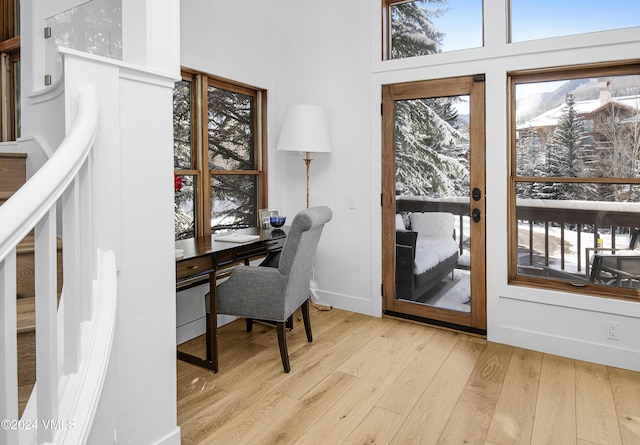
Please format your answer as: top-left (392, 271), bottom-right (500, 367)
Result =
top-left (391, 0), bottom-right (469, 196)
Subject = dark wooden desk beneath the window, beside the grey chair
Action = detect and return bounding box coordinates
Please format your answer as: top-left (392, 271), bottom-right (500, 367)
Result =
top-left (176, 227), bottom-right (286, 372)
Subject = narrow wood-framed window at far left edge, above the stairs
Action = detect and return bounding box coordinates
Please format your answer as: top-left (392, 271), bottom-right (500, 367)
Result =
top-left (0, 0), bottom-right (20, 141)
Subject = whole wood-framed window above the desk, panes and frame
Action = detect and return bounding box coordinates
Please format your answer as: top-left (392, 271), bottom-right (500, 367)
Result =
top-left (173, 70), bottom-right (267, 239)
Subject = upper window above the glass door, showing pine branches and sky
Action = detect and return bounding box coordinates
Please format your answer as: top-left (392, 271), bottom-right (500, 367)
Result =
top-left (382, 0), bottom-right (482, 59)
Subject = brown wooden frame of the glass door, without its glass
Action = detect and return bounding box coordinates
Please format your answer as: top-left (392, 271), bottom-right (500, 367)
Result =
top-left (381, 75), bottom-right (487, 333)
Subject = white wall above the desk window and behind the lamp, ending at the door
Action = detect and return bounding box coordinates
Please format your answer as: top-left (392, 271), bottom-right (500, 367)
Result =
top-left (181, 0), bottom-right (381, 322)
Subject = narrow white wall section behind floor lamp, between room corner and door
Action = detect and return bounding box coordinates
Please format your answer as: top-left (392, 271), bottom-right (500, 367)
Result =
top-left (275, 0), bottom-right (382, 316)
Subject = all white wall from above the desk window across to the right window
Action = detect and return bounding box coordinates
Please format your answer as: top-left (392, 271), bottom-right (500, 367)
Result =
top-left (182, 0), bottom-right (640, 370)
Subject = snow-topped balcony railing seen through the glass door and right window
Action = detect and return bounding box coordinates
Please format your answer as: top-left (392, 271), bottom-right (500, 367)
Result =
top-left (396, 196), bottom-right (640, 282)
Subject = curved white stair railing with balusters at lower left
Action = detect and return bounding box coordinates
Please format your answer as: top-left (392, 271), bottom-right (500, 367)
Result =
top-left (0, 86), bottom-right (117, 444)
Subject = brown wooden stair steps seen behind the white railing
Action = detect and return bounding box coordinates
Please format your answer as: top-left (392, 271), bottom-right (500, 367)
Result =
top-left (0, 153), bottom-right (62, 415)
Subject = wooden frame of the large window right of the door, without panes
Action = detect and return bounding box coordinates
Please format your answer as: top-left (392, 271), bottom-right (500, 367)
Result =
top-left (507, 60), bottom-right (640, 302)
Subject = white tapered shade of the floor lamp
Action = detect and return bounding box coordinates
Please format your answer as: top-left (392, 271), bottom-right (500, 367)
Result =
top-left (278, 105), bottom-right (331, 153)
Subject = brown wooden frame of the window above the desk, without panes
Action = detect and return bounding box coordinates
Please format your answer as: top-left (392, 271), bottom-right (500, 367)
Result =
top-left (174, 67), bottom-right (268, 237)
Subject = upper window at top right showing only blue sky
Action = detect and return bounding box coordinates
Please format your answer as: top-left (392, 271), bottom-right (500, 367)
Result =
top-left (510, 0), bottom-right (640, 42)
